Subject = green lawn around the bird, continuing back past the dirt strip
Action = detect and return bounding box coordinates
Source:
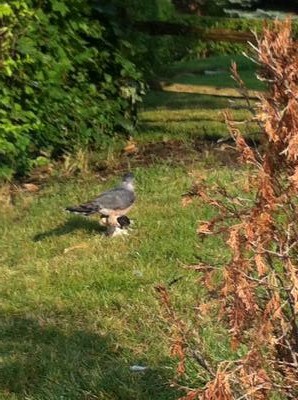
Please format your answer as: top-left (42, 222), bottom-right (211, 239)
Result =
top-left (0, 54), bottom-right (256, 400)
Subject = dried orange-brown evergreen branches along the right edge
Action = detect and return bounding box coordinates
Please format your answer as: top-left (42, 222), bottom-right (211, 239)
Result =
top-left (161, 20), bottom-right (298, 400)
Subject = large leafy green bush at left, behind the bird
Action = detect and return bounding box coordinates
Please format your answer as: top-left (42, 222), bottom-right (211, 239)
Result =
top-left (0, 0), bottom-right (144, 179)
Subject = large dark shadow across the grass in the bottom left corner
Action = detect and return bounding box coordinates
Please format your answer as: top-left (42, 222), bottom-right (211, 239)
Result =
top-left (0, 316), bottom-right (177, 400)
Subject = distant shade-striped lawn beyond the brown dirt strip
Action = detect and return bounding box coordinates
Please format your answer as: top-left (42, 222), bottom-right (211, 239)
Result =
top-left (140, 55), bottom-right (264, 142)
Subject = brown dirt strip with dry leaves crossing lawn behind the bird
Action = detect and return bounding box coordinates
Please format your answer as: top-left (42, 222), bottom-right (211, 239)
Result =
top-left (12, 139), bottom-right (254, 191)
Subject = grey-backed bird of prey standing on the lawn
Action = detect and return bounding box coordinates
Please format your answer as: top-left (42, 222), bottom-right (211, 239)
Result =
top-left (66, 172), bottom-right (136, 236)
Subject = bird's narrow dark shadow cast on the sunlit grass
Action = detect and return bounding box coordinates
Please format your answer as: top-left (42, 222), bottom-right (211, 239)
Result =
top-left (33, 216), bottom-right (106, 242)
